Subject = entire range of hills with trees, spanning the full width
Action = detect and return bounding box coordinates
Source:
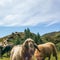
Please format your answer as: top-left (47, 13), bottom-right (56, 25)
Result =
top-left (0, 29), bottom-right (60, 50)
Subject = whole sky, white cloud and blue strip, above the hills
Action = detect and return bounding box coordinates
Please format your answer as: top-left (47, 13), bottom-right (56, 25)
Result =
top-left (0, 0), bottom-right (60, 37)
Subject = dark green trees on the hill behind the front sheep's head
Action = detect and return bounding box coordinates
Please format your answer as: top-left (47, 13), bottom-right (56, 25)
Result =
top-left (10, 28), bottom-right (43, 45)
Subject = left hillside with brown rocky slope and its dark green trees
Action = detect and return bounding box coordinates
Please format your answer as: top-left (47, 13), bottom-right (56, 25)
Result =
top-left (0, 28), bottom-right (40, 44)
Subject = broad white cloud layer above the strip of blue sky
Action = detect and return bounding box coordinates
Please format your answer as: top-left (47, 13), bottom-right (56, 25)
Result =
top-left (0, 0), bottom-right (60, 27)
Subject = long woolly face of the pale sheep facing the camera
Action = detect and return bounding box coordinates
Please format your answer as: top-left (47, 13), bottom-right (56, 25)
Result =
top-left (24, 38), bottom-right (38, 55)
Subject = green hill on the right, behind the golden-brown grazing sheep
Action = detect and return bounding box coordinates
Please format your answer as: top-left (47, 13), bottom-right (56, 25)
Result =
top-left (41, 31), bottom-right (60, 51)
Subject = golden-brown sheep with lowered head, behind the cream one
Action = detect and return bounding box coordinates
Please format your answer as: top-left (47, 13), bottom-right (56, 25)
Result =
top-left (34, 42), bottom-right (57, 60)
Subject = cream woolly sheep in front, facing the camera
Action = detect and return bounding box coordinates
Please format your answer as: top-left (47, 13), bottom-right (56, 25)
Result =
top-left (10, 38), bottom-right (39, 60)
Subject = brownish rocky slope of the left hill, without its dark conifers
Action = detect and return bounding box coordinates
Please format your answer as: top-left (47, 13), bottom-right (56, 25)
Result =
top-left (0, 32), bottom-right (35, 42)
